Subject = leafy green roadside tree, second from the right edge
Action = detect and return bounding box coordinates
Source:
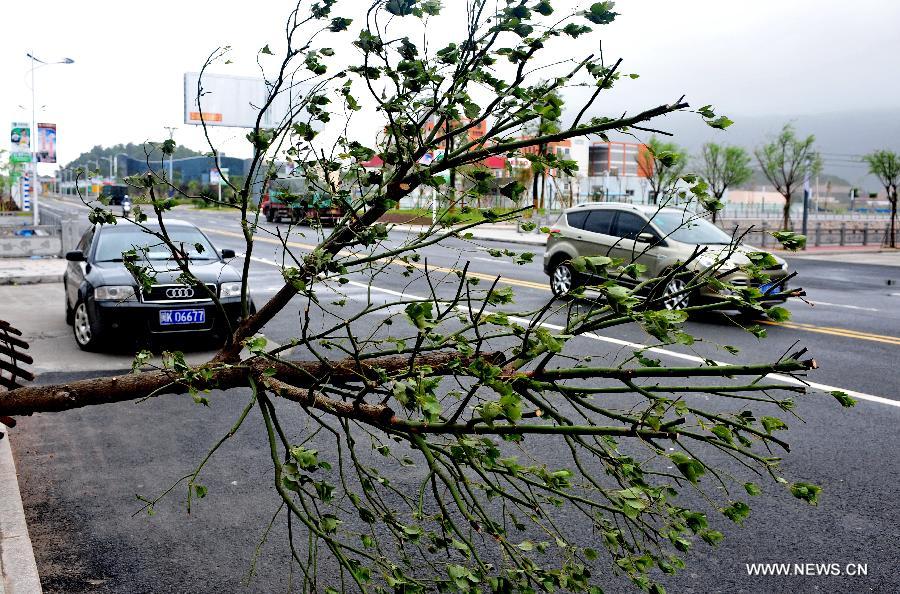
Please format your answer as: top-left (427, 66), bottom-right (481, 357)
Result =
top-left (753, 124), bottom-right (822, 231)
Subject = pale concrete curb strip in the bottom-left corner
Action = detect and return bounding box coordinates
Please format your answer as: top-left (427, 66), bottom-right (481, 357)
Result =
top-left (0, 428), bottom-right (43, 594)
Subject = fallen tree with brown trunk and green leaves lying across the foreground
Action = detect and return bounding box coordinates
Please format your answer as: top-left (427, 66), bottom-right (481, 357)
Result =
top-left (0, 0), bottom-right (832, 594)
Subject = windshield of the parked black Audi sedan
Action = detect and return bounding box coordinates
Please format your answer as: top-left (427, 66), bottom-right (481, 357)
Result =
top-left (94, 225), bottom-right (217, 262)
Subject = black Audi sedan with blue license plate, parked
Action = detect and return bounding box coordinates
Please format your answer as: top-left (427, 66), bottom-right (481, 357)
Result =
top-left (63, 220), bottom-right (253, 351)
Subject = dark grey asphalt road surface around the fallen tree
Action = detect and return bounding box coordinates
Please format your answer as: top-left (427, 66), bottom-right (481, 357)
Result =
top-left (13, 201), bottom-right (900, 592)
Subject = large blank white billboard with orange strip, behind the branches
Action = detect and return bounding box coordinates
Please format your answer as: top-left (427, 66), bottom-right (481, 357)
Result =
top-left (184, 72), bottom-right (296, 128)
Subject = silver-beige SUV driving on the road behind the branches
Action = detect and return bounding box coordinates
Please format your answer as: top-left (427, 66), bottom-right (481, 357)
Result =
top-left (544, 203), bottom-right (788, 309)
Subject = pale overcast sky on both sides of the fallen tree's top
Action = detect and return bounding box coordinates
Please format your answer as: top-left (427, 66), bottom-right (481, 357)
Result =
top-left (0, 0), bottom-right (900, 172)
